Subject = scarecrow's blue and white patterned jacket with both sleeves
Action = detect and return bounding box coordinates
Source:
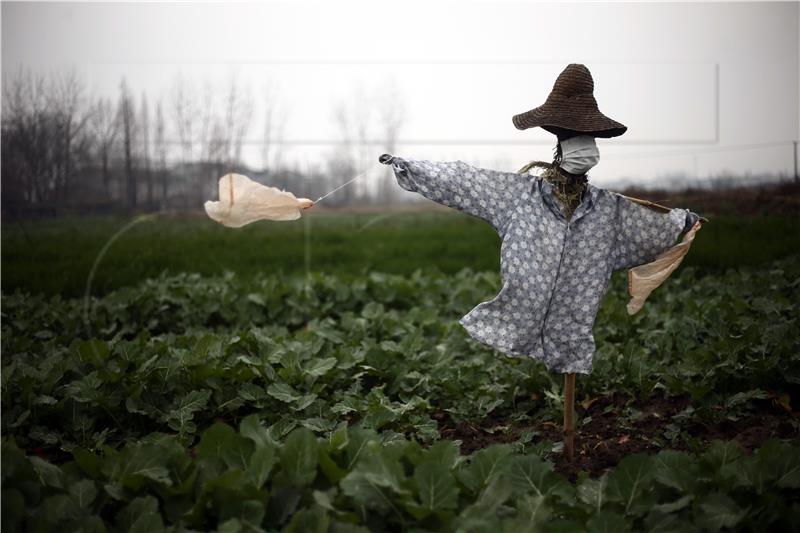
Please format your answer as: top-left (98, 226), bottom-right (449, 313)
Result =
top-left (392, 157), bottom-right (696, 374)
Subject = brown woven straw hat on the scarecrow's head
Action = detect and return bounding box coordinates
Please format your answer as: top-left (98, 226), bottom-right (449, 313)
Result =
top-left (513, 63), bottom-right (628, 137)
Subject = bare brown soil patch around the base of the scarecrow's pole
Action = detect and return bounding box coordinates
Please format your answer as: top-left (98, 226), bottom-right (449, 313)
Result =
top-left (434, 393), bottom-right (800, 482)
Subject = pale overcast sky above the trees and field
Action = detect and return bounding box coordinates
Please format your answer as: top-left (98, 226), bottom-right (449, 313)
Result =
top-left (2, 0), bottom-right (800, 185)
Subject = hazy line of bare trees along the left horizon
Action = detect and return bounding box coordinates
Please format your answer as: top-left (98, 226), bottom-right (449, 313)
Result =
top-left (0, 69), bottom-right (403, 216)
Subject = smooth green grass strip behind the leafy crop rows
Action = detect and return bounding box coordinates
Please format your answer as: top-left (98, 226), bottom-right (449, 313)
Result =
top-left (2, 211), bottom-right (800, 297)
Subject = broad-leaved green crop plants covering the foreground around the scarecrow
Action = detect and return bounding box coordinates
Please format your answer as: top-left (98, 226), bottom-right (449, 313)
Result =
top-left (0, 245), bottom-right (800, 531)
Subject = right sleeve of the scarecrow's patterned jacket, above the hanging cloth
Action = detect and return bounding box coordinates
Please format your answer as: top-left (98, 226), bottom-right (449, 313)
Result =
top-left (614, 194), bottom-right (694, 270)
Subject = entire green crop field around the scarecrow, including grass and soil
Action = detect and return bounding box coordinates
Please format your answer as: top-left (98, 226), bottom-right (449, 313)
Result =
top-left (0, 211), bottom-right (800, 533)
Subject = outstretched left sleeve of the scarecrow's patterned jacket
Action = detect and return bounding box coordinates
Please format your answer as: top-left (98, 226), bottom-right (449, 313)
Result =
top-left (392, 157), bottom-right (530, 234)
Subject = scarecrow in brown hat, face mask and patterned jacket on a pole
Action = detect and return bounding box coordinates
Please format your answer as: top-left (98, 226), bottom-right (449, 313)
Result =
top-left (379, 64), bottom-right (705, 460)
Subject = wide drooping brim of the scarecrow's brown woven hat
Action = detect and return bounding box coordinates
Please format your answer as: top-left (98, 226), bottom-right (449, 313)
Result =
top-left (512, 98), bottom-right (628, 137)
